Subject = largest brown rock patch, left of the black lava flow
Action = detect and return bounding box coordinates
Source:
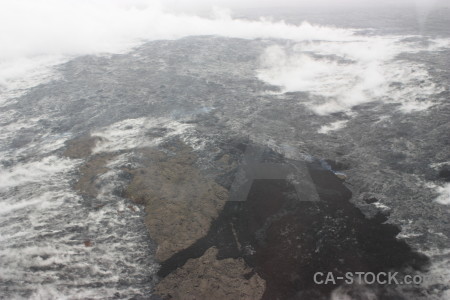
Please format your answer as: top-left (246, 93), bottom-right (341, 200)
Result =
top-left (125, 142), bottom-right (228, 261)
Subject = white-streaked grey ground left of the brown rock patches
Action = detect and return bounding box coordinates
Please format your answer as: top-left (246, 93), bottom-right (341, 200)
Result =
top-left (0, 151), bottom-right (155, 299)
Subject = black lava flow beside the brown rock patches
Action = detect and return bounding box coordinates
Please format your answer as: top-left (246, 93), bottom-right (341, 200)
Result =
top-left (158, 144), bottom-right (429, 300)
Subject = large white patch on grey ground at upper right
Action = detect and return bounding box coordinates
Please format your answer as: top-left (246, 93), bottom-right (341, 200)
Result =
top-left (257, 33), bottom-right (450, 115)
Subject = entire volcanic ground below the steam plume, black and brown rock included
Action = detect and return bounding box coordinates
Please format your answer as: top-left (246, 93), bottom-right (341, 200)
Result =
top-left (0, 4), bottom-right (450, 299)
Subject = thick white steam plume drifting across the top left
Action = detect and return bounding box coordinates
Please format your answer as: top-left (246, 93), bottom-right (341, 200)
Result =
top-left (0, 0), bottom-right (353, 93)
